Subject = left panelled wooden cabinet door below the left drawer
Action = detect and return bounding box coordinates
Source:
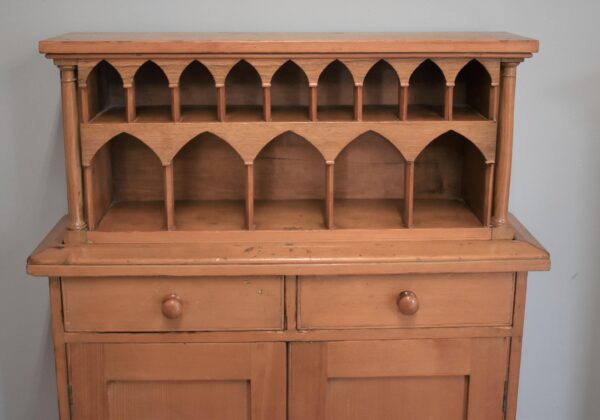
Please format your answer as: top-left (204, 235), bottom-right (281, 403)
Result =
top-left (68, 343), bottom-right (286, 420)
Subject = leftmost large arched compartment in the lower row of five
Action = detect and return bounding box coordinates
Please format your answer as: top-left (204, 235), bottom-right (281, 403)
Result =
top-left (88, 134), bottom-right (165, 231)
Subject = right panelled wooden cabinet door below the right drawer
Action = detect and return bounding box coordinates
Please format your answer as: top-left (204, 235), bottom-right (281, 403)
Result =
top-left (289, 338), bottom-right (508, 420)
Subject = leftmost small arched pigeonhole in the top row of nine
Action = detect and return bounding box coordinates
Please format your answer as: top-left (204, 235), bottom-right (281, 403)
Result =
top-left (87, 60), bottom-right (125, 123)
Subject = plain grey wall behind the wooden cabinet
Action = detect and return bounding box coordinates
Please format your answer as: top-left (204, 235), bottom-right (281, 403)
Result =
top-left (0, 0), bottom-right (600, 420)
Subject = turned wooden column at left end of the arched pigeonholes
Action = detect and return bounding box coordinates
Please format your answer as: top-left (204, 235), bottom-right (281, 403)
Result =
top-left (60, 65), bottom-right (86, 230)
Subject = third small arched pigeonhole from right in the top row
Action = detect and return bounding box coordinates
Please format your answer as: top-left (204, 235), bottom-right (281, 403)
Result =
top-left (363, 60), bottom-right (400, 121)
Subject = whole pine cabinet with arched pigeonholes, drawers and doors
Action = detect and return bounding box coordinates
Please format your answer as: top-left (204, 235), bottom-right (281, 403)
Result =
top-left (27, 33), bottom-right (550, 420)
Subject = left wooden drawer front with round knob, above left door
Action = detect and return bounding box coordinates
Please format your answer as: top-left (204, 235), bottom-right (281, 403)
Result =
top-left (62, 276), bottom-right (284, 332)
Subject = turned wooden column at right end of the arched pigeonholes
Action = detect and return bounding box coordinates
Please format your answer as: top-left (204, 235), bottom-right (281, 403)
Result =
top-left (492, 63), bottom-right (518, 226)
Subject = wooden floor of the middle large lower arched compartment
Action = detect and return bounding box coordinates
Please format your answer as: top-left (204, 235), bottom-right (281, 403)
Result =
top-left (254, 200), bottom-right (325, 230)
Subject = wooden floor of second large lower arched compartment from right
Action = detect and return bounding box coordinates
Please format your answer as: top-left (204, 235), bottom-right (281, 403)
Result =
top-left (334, 199), bottom-right (404, 229)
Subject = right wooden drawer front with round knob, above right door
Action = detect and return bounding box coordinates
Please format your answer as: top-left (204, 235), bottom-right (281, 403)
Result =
top-left (298, 273), bottom-right (515, 329)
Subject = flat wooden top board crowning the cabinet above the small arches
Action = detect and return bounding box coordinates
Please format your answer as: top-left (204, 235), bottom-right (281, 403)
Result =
top-left (40, 32), bottom-right (538, 58)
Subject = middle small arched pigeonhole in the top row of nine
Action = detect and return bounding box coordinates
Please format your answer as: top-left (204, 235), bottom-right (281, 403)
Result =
top-left (271, 60), bottom-right (309, 121)
